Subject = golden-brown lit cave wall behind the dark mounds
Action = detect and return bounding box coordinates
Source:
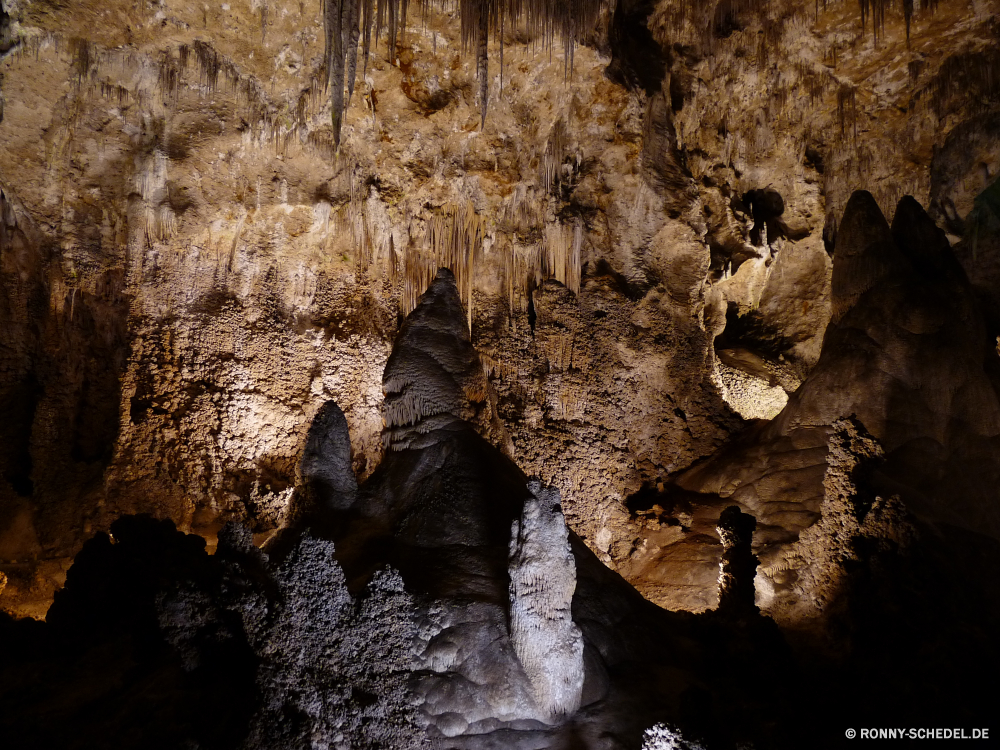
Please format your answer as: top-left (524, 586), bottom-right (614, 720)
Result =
top-left (0, 0), bottom-right (1000, 615)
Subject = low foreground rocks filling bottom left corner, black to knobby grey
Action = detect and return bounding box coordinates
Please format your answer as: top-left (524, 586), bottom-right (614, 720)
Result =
top-left (0, 516), bottom-right (423, 750)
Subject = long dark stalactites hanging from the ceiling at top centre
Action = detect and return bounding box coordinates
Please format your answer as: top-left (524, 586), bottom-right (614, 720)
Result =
top-left (323, 0), bottom-right (606, 145)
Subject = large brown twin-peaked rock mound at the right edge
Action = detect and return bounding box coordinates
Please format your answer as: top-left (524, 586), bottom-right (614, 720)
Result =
top-left (649, 193), bottom-right (1000, 618)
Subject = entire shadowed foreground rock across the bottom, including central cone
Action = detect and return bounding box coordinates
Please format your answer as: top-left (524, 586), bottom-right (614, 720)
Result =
top-left (0, 262), bottom-right (1000, 750)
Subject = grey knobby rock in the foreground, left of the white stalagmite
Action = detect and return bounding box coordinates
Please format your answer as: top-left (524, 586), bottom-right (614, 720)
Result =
top-left (238, 537), bottom-right (426, 750)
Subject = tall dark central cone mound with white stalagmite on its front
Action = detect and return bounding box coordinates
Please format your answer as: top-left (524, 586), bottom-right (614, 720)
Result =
top-left (296, 276), bottom-right (796, 748)
